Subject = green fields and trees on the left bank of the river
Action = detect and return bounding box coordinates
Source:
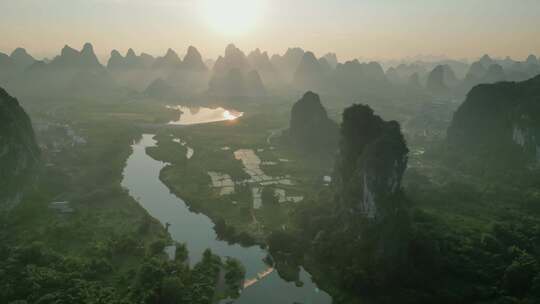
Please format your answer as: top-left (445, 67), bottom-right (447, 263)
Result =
top-left (0, 100), bottom-right (244, 303)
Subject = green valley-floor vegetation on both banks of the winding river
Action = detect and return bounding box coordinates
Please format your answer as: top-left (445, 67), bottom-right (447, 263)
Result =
top-left (7, 89), bottom-right (540, 303)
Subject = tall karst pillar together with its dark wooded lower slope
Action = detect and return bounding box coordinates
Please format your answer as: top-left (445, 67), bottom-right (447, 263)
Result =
top-left (298, 105), bottom-right (410, 296)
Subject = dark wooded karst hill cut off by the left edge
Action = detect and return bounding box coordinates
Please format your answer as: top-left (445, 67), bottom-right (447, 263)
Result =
top-left (0, 88), bottom-right (39, 208)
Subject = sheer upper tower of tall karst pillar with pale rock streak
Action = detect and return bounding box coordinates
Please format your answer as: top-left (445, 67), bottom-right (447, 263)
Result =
top-left (335, 105), bottom-right (408, 219)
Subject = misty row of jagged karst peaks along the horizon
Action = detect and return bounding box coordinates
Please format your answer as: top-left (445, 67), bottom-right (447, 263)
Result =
top-left (0, 43), bottom-right (540, 98)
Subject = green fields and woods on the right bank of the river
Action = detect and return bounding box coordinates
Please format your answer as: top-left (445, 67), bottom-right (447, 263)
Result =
top-left (144, 95), bottom-right (540, 303)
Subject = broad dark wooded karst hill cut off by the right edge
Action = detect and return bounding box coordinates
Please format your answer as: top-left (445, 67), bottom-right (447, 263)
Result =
top-left (448, 76), bottom-right (540, 164)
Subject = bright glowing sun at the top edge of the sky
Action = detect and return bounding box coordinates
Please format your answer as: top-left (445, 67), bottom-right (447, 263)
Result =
top-left (201, 0), bottom-right (266, 36)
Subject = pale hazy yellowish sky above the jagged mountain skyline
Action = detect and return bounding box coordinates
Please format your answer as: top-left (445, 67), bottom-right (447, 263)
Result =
top-left (0, 0), bottom-right (540, 59)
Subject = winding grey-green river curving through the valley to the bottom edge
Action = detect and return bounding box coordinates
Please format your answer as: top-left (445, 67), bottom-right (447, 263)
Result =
top-left (122, 134), bottom-right (332, 304)
